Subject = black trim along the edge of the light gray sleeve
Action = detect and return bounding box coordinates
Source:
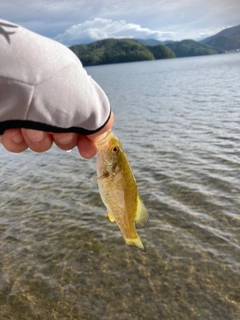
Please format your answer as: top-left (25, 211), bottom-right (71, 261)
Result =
top-left (0, 111), bottom-right (111, 136)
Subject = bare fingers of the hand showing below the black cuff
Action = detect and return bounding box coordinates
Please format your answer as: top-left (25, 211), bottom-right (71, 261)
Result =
top-left (0, 113), bottom-right (114, 159)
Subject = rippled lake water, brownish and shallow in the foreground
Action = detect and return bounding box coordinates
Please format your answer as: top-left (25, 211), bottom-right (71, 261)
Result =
top-left (0, 53), bottom-right (240, 320)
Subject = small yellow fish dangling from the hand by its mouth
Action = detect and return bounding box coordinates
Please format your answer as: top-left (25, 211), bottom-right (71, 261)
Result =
top-left (95, 130), bottom-right (148, 253)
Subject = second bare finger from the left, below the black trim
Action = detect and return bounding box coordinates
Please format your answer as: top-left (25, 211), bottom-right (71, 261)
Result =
top-left (21, 129), bottom-right (53, 152)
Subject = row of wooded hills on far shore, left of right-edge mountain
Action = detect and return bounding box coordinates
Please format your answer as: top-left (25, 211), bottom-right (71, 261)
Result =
top-left (70, 39), bottom-right (218, 66)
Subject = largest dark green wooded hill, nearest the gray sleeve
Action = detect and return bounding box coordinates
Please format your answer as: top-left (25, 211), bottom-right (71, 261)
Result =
top-left (70, 39), bottom-right (175, 66)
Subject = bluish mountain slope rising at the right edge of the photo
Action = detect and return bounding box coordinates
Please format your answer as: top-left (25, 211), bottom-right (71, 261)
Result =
top-left (201, 25), bottom-right (240, 51)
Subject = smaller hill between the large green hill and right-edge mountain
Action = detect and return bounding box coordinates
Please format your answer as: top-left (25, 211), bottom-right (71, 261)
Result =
top-left (166, 40), bottom-right (223, 57)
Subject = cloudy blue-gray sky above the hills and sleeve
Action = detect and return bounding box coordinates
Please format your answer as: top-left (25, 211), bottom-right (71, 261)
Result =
top-left (0, 0), bottom-right (240, 46)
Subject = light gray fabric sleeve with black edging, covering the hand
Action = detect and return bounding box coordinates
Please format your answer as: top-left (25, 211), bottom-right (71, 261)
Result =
top-left (0, 20), bottom-right (111, 135)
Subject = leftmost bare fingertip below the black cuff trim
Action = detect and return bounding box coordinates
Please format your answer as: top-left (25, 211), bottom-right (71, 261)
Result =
top-left (2, 129), bottom-right (28, 153)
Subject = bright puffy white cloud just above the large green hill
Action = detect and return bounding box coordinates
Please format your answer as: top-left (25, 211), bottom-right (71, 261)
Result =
top-left (55, 18), bottom-right (175, 46)
